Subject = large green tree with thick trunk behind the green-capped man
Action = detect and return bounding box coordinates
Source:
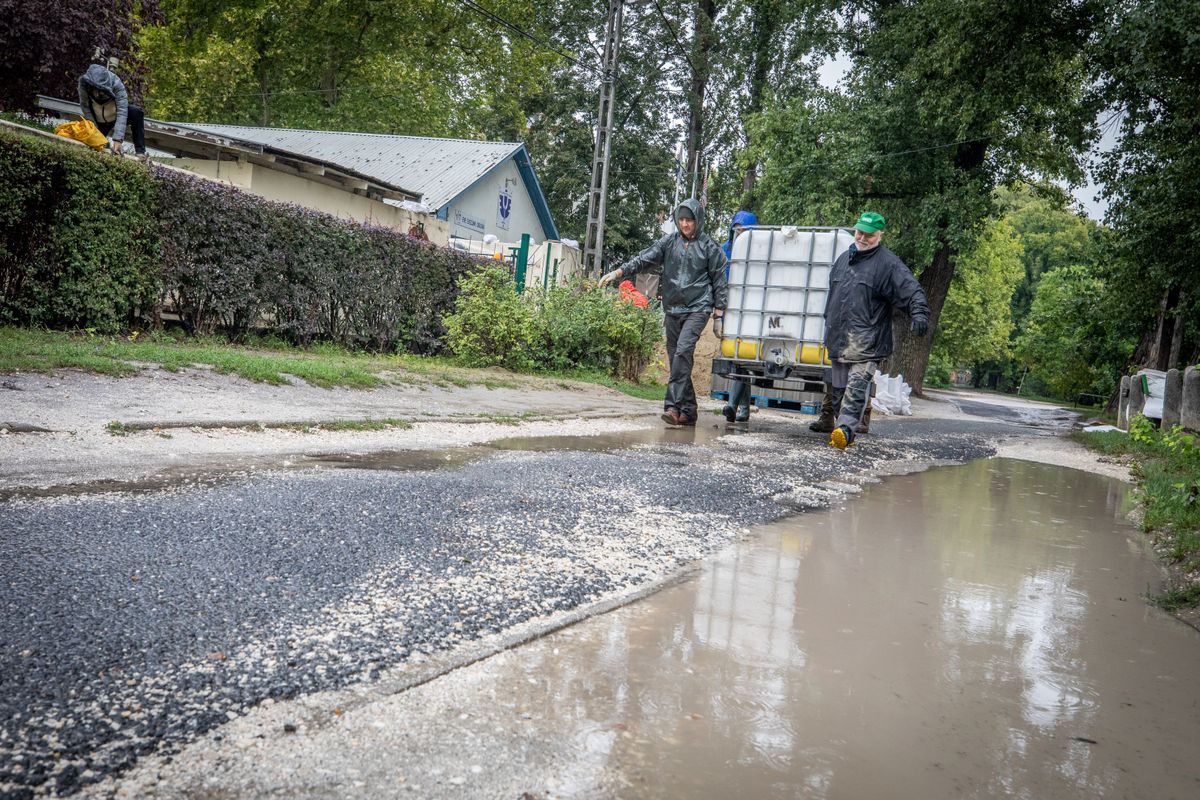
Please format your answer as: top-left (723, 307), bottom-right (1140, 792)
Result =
top-left (764, 0), bottom-right (1097, 392)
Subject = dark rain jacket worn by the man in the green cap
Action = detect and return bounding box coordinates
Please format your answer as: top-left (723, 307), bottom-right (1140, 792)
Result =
top-left (826, 245), bottom-right (929, 362)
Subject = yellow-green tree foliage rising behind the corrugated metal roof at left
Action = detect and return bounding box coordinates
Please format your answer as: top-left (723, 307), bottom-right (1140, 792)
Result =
top-left (140, 0), bottom-right (559, 140)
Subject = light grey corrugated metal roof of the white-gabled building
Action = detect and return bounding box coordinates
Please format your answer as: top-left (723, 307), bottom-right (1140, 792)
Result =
top-left (172, 122), bottom-right (522, 209)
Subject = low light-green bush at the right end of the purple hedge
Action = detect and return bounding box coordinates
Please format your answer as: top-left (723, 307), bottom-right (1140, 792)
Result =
top-left (445, 266), bottom-right (661, 383)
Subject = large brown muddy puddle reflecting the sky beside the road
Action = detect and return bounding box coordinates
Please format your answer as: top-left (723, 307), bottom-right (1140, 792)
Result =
top-left (476, 461), bottom-right (1200, 799)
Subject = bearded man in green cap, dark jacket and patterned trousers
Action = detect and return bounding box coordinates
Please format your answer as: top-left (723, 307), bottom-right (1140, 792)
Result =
top-left (824, 211), bottom-right (929, 450)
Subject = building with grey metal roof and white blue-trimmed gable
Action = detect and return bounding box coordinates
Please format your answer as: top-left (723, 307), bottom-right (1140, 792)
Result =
top-left (164, 122), bottom-right (559, 241)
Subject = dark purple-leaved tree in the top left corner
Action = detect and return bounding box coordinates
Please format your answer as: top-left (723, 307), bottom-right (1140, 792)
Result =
top-left (0, 0), bottom-right (158, 110)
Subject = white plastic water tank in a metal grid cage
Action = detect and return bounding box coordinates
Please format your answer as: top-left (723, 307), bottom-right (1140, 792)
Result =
top-left (725, 227), bottom-right (854, 357)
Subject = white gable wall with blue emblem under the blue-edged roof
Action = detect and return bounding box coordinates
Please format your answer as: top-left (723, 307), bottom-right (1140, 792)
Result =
top-left (446, 158), bottom-right (546, 242)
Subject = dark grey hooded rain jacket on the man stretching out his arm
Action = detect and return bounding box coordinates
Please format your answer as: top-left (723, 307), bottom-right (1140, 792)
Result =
top-left (620, 198), bottom-right (730, 314)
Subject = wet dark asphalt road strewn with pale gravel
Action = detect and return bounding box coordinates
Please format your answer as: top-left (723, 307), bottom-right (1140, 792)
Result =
top-left (0, 420), bottom-right (1013, 798)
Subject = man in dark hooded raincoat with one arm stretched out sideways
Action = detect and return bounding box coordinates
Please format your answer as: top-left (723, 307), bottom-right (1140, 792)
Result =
top-left (600, 198), bottom-right (728, 425)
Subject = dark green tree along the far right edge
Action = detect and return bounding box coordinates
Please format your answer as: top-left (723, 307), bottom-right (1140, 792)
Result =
top-left (1097, 0), bottom-right (1200, 369)
